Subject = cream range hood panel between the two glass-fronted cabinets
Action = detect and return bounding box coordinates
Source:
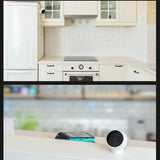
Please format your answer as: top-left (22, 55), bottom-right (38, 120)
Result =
top-left (64, 1), bottom-right (98, 18)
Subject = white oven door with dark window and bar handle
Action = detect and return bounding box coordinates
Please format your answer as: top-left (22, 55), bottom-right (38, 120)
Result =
top-left (63, 72), bottom-right (99, 82)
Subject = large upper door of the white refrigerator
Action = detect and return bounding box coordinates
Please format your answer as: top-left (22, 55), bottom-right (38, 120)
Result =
top-left (4, 2), bottom-right (37, 69)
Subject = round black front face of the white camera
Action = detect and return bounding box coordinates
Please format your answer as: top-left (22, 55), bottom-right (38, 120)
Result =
top-left (106, 130), bottom-right (123, 147)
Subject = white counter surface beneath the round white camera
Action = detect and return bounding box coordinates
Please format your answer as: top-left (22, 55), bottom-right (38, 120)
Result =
top-left (4, 131), bottom-right (156, 160)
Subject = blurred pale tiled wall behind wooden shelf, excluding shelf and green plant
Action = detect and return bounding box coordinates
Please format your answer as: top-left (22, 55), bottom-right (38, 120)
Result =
top-left (4, 85), bottom-right (156, 139)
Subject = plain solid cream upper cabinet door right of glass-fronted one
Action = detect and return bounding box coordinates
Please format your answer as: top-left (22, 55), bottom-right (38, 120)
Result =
top-left (119, 1), bottom-right (137, 23)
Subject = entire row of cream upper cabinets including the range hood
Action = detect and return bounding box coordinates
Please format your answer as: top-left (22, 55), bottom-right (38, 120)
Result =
top-left (41, 1), bottom-right (137, 26)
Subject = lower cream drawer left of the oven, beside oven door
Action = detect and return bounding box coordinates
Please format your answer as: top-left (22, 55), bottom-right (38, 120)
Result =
top-left (39, 71), bottom-right (62, 81)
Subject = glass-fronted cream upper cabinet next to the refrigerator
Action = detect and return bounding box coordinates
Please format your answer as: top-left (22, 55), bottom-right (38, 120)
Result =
top-left (41, 1), bottom-right (64, 26)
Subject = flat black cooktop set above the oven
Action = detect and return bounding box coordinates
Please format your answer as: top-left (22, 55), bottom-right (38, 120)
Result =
top-left (64, 56), bottom-right (98, 61)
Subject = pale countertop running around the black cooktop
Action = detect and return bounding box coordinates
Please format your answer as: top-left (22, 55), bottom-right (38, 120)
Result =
top-left (38, 57), bottom-right (156, 76)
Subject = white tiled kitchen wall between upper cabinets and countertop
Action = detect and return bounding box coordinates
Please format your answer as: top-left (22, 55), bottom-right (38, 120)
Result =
top-left (45, 1), bottom-right (156, 63)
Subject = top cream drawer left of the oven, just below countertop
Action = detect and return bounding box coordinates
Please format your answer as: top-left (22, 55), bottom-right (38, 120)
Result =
top-left (39, 63), bottom-right (62, 72)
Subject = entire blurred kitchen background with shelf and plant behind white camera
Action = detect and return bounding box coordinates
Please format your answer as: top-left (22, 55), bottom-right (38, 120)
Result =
top-left (4, 85), bottom-right (156, 141)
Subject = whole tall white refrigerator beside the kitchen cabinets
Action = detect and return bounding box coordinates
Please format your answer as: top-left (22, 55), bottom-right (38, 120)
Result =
top-left (3, 2), bottom-right (43, 81)
